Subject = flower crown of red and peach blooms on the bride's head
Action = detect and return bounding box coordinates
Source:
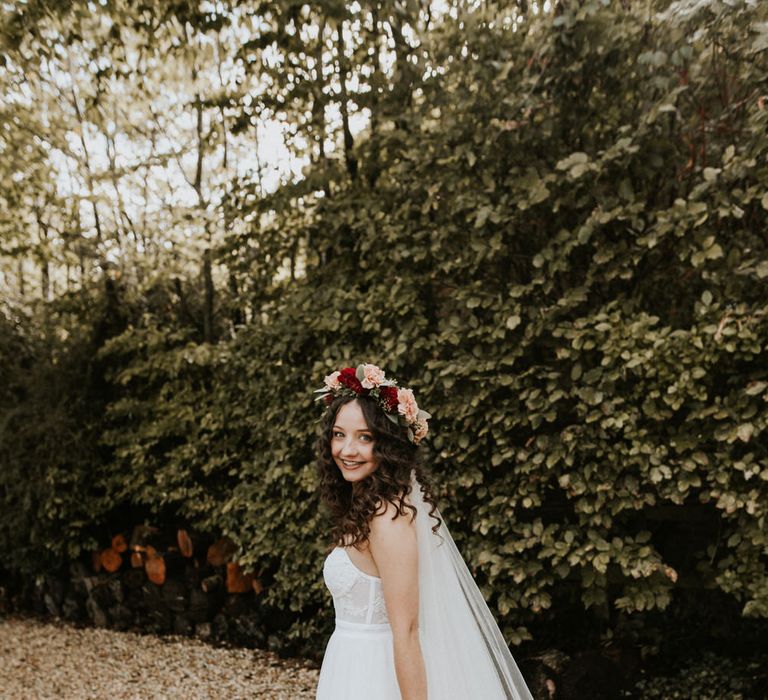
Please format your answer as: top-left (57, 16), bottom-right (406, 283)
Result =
top-left (314, 364), bottom-right (432, 445)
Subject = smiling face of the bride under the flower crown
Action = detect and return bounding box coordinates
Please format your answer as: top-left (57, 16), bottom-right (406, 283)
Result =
top-left (331, 401), bottom-right (379, 481)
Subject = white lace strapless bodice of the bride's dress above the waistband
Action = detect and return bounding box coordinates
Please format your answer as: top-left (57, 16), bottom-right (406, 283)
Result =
top-left (323, 547), bottom-right (389, 625)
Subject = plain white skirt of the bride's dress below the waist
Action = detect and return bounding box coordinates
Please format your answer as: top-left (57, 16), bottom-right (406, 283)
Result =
top-left (316, 620), bottom-right (401, 700)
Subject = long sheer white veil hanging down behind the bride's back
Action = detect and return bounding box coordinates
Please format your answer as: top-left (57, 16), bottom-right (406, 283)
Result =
top-left (410, 474), bottom-right (533, 700)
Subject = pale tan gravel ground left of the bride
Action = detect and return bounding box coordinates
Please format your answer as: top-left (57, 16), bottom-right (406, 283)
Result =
top-left (0, 616), bottom-right (318, 700)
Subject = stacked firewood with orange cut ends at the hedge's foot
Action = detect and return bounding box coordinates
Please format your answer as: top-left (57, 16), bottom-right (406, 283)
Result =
top-left (15, 525), bottom-right (280, 645)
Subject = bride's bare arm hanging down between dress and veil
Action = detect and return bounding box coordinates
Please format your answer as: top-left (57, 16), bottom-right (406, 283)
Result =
top-left (369, 503), bottom-right (427, 700)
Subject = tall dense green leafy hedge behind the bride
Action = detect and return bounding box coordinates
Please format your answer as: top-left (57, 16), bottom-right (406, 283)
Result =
top-left (0, 2), bottom-right (768, 664)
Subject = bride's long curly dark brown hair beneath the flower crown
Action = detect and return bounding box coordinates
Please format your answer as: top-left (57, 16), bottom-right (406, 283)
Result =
top-left (316, 396), bottom-right (442, 547)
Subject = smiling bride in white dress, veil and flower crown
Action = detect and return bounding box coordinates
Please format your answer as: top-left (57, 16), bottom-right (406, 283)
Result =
top-left (317, 364), bottom-right (532, 700)
